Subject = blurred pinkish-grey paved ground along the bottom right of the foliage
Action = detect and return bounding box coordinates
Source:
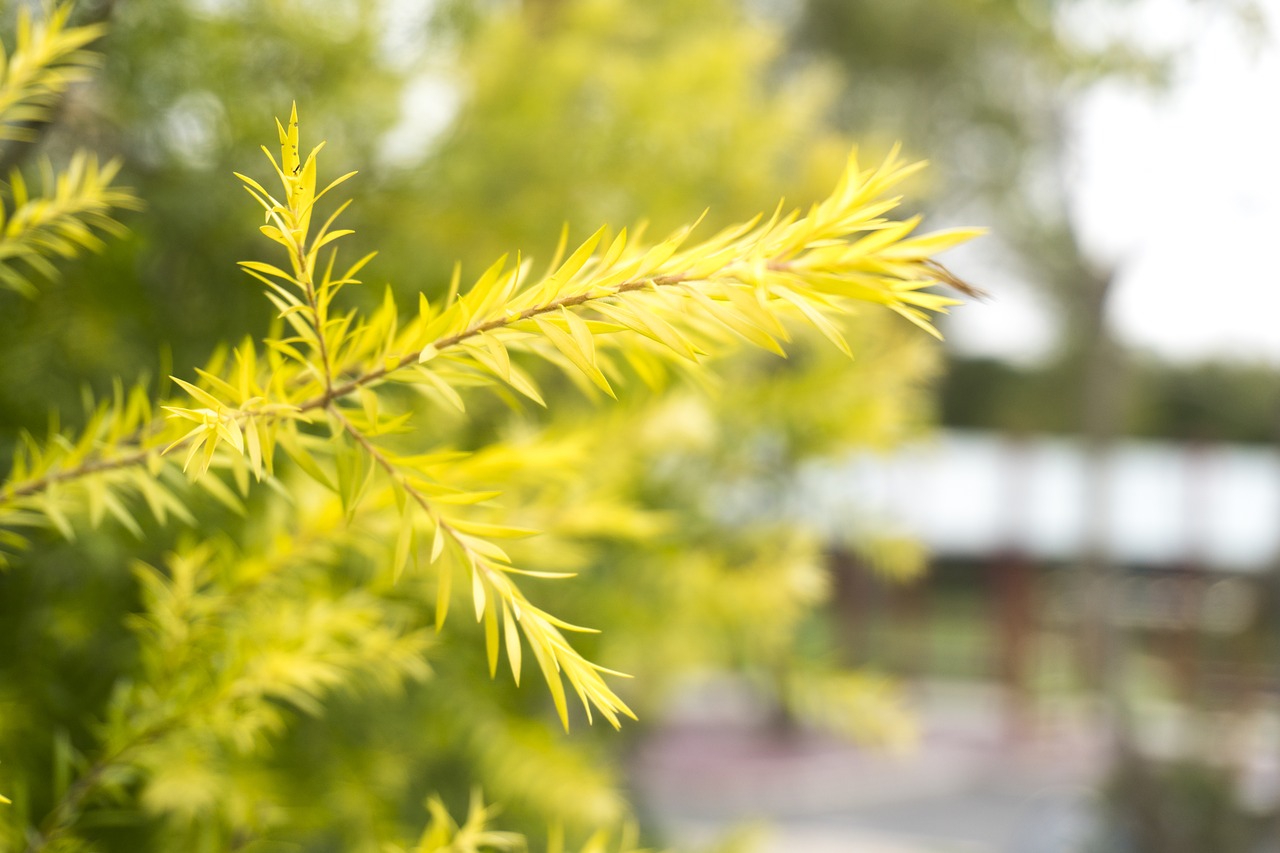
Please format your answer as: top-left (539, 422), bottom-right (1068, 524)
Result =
top-left (634, 684), bottom-right (1105, 853)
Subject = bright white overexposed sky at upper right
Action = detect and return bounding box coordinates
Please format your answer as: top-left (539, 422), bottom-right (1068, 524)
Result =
top-left (950, 0), bottom-right (1280, 365)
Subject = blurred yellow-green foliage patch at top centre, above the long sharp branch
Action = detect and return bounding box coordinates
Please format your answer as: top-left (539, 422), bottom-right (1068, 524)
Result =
top-left (404, 0), bottom-right (849, 264)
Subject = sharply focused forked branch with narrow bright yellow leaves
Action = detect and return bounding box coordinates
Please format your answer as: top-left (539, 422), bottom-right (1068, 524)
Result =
top-left (0, 104), bottom-right (973, 725)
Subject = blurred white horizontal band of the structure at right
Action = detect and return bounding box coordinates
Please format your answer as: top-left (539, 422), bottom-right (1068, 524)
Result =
top-left (787, 432), bottom-right (1280, 573)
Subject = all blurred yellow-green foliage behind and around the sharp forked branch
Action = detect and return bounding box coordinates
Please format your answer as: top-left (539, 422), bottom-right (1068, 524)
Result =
top-left (0, 0), bottom-right (988, 849)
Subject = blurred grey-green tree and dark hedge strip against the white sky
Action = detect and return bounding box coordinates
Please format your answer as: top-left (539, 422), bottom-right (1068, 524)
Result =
top-left (794, 0), bottom-right (1280, 441)
